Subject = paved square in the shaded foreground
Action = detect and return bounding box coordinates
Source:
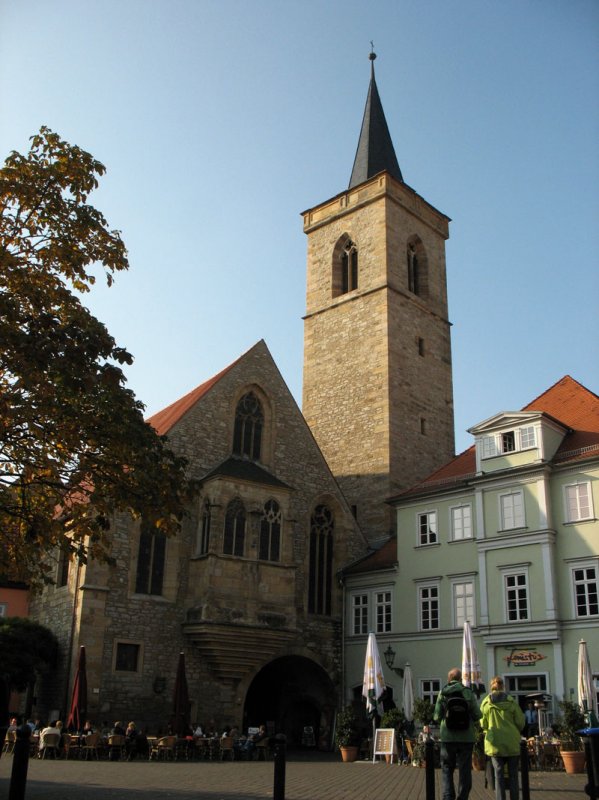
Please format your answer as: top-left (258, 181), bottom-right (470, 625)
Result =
top-left (0, 755), bottom-right (586, 800)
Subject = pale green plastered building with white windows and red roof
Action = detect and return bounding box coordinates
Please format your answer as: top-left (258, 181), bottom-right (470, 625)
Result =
top-left (343, 376), bottom-right (599, 722)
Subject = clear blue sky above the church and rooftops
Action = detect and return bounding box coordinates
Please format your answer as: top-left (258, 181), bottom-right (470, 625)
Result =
top-left (0, 0), bottom-right (599, 452)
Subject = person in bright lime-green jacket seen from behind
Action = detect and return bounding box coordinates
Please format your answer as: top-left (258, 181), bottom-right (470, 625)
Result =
top-left (480, 675), bottom-right (526, 800)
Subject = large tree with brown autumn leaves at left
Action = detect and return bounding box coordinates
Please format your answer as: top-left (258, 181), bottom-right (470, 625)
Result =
top-left (0, 127), bottom-right (187, 587)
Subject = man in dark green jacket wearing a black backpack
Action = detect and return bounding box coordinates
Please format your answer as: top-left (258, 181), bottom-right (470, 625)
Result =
top-left (434, 667), bottom-right (481, 800)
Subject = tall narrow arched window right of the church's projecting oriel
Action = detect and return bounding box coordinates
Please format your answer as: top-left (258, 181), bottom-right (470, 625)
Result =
top-left (308, 505), bottom-right (335, 614)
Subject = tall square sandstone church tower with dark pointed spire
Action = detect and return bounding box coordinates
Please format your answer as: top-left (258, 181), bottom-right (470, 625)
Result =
top-left (302, 53), bottom-right (454, 543)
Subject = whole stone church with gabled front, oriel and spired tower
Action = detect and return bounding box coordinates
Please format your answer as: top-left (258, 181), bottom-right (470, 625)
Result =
top-left (31, 54), bottom-right (454, 748)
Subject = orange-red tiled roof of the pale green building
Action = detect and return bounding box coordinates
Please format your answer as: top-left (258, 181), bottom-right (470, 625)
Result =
top-left (391, 375), bottom-right (599, 500)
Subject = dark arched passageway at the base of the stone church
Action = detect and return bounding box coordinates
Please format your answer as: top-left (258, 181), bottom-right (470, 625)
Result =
top-left (243, 656), bottom-right (336, 750)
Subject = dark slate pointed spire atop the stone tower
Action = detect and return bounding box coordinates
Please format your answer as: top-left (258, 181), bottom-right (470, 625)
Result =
top-left (349, 49), bottom-right (403, 189)
